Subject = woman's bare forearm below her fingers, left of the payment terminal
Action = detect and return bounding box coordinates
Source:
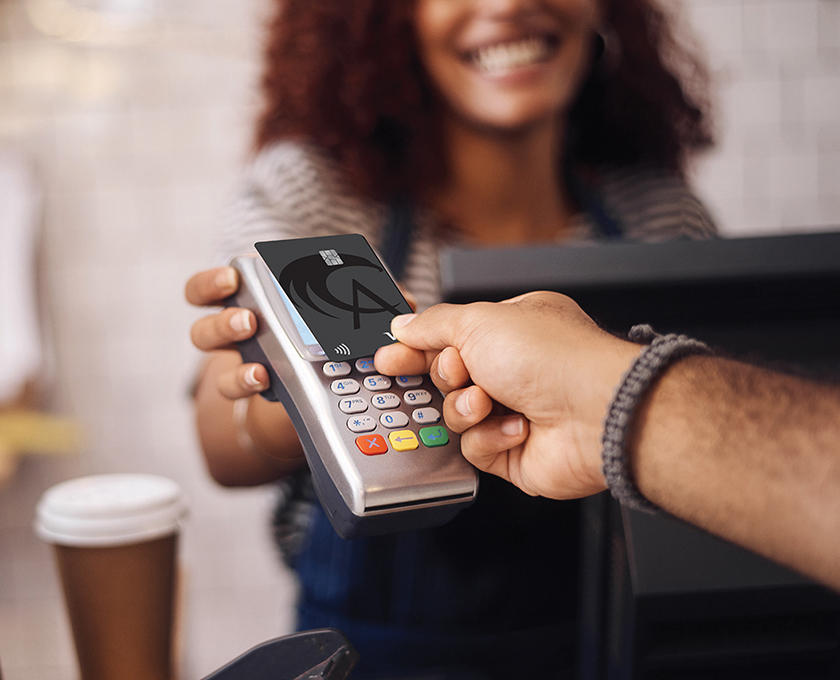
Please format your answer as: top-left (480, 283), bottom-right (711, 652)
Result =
top-left (195, 351), bottom-right (302, 486)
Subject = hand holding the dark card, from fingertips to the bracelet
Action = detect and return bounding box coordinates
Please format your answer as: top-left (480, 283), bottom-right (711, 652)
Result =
top-left (376, 293), bottom-right (639, 498)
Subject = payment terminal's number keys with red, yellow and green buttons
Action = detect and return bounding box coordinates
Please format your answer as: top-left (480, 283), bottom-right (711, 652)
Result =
top-left (323, 358), bottom-right (449, 456)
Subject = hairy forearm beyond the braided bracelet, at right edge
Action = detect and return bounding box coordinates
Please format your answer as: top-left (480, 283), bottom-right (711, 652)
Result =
top-left (629, 357), bottom-right (840, 589)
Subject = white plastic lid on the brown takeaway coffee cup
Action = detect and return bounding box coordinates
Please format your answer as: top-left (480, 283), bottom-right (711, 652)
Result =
top-left (35, 474), bottom-right (186, 547)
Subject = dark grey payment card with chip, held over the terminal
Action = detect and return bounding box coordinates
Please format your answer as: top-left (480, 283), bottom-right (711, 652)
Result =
top-left (255, 234), bottom-right (411, 361)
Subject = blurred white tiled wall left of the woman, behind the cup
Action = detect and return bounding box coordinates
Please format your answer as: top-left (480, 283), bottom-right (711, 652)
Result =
top-left (0, 0), bottom-right (295, 680)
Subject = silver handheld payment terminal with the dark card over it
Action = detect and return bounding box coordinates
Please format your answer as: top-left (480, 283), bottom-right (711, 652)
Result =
top-left (226, 234), bottom-right (478, 538)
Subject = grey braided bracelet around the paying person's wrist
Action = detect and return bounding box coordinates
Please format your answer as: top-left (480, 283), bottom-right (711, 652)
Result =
top-left (601, 326), bottom-right (712, 512)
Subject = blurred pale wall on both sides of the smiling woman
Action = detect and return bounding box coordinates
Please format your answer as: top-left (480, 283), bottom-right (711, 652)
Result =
top-left (0, 0), bottom-right (840, 680)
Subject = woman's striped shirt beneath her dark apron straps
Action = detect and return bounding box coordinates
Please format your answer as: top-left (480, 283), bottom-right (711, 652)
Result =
top-left (220, 142), bottom-right (715, 311)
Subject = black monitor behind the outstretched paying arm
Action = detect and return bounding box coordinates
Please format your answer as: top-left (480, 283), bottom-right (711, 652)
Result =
top-left (441, 232), bottom-right (840, 680)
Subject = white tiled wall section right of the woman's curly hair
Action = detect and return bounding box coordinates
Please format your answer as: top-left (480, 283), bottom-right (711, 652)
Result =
top-left (683, 0), bottom-right (840, 235)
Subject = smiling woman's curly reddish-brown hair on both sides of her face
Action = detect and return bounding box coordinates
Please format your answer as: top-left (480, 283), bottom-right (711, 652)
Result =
top-left (256, 0), bottom-right (712, 198)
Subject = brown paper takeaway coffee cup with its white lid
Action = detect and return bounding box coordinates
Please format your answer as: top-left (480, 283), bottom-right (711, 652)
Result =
top-left (35, 474), bottom-right (185, 680)
